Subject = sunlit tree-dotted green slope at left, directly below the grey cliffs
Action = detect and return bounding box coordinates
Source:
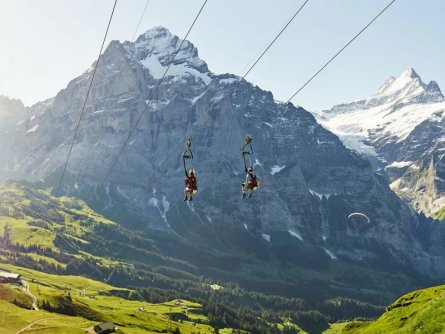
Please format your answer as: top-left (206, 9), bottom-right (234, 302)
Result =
top-left (0, 182), bottom-right (196, 279)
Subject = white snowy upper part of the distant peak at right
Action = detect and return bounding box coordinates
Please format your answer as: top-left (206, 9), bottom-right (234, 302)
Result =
top-left (315, 69), bottom-right (445, 159)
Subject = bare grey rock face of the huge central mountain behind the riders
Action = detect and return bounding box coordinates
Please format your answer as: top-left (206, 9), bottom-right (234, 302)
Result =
top-left (1, 28), bottom-right (445, 277)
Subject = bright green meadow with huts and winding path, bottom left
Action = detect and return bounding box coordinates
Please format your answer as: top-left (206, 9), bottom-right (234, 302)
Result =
top-left (0, 265), bottom-right (220, 334)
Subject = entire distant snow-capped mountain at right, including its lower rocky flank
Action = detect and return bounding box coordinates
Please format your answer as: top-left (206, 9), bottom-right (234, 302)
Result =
top-left (317, 69), bottom-right (445, 215)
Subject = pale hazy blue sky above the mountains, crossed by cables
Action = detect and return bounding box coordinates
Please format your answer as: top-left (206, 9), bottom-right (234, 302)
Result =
top-left (0, 0), bottom-right (445, 110)
